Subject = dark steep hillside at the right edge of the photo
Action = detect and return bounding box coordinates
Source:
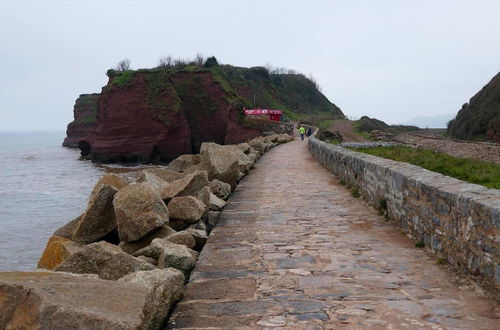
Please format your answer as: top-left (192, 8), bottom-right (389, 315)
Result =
top-left (448, 73), bottom-right (500, 143)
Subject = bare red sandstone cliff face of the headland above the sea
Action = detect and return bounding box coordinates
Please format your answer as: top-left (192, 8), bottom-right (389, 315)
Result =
top-left (64, 70), bottom-right (261, 163)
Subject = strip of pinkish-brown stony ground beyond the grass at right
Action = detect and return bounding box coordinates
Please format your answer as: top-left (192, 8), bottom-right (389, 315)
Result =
top-left (395, 133), bottom-right (500, 164)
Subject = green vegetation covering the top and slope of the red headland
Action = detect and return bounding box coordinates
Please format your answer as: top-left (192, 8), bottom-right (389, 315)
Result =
top-left (105, 58), bottom-right (344, 123)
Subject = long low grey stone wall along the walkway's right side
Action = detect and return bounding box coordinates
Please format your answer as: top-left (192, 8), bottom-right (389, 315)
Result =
top-left (309, 137), bottom-right (500, 292)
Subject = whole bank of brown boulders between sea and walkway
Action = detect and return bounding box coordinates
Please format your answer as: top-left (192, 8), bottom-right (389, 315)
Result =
top-left (0, 134), bottom-right (292, 329)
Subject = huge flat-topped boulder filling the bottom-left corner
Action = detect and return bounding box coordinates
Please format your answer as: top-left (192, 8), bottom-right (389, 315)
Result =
top-left (0, 271), bottom-right (164, 330)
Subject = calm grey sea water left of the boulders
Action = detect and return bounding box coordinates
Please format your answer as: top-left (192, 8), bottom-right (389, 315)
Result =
top-left (0, 132), bottom-right (104, 270)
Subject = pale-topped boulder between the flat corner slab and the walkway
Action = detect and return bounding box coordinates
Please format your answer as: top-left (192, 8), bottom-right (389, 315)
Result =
top-left (118, 268), bottom-right (184, 329)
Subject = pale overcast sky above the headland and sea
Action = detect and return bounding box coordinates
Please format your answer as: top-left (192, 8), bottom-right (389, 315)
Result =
top-left (0, 0), bottom-right (500, 131)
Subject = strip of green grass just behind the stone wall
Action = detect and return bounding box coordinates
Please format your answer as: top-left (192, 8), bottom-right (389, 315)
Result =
top-left (354, 146), bottom-right (500, 189)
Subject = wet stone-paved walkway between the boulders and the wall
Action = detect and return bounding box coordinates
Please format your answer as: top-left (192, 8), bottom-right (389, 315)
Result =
top-left (169, 141), bottom-right (500, 329)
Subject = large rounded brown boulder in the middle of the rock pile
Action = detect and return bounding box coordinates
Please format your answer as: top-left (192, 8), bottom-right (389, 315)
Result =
top-left (113, 182), bottom-right (168, 242)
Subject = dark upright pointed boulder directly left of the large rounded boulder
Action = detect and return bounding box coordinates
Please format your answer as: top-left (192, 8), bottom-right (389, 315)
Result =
top-left (72, 183), bottom-right (118, 243)
